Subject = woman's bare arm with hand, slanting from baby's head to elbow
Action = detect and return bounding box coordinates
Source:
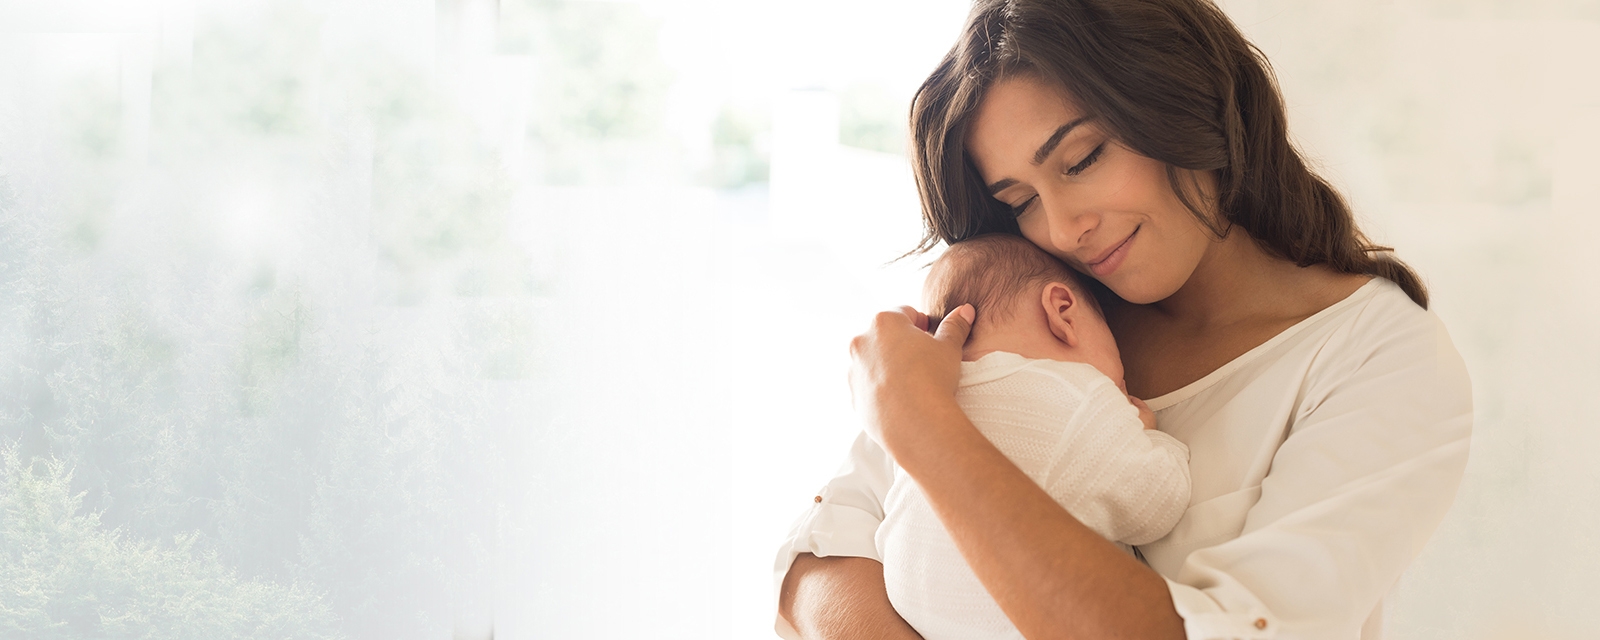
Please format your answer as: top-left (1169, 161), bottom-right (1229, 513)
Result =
top-left (851, 306), bottom-right (1184, 640)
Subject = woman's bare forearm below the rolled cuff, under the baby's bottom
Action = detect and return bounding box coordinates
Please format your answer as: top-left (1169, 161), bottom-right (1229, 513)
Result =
top-left (778, 554), bottom-right (922, 640)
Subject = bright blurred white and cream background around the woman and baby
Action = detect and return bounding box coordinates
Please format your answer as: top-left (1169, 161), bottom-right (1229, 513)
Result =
top-left (0, 0), bottom-right (1600, 638)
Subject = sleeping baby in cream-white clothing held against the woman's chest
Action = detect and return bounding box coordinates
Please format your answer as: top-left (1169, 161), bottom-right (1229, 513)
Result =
top-left (877, 235), bottom-right (1189, 640)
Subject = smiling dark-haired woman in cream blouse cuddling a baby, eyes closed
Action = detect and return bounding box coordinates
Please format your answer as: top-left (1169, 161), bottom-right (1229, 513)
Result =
top-left (778, 0), bottom-right (1472, 640)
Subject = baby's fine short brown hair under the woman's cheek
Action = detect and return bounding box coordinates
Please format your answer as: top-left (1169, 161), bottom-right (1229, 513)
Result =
top-left (923, 234), bottom-right (1099, 322)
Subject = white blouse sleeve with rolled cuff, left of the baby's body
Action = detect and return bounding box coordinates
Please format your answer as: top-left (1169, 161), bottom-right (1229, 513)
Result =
top-left (773, 432), bottom-right (894, 640)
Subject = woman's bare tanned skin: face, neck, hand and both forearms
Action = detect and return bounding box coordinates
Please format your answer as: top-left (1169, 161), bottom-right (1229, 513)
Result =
top-left (779, 77), bottom-right (1368, 640)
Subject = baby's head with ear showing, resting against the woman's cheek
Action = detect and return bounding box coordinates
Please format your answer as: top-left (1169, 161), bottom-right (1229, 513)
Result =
top-left (922, 234), bottom-right (1123, 387)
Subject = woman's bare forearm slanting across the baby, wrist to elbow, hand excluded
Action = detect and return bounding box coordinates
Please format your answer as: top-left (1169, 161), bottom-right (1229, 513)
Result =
top-left (877, 398), bottom-right (1184, 640)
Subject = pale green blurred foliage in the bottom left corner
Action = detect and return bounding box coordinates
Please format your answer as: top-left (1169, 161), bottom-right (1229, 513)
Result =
top-left (0, 448), bottom-right (339, 640)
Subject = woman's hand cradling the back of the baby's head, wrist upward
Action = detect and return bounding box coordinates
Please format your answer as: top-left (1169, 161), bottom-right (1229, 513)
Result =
top-left (850, 304), bottom-right (976, 454)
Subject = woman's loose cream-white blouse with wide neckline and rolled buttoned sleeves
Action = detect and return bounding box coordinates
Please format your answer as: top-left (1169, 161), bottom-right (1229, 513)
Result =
top-left (776, 278), bottom-right (1472, 640)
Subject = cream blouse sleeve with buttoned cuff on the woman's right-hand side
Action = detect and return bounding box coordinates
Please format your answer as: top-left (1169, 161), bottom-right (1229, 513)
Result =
top-left (1168, 307), bottom-right (1472, 640)
